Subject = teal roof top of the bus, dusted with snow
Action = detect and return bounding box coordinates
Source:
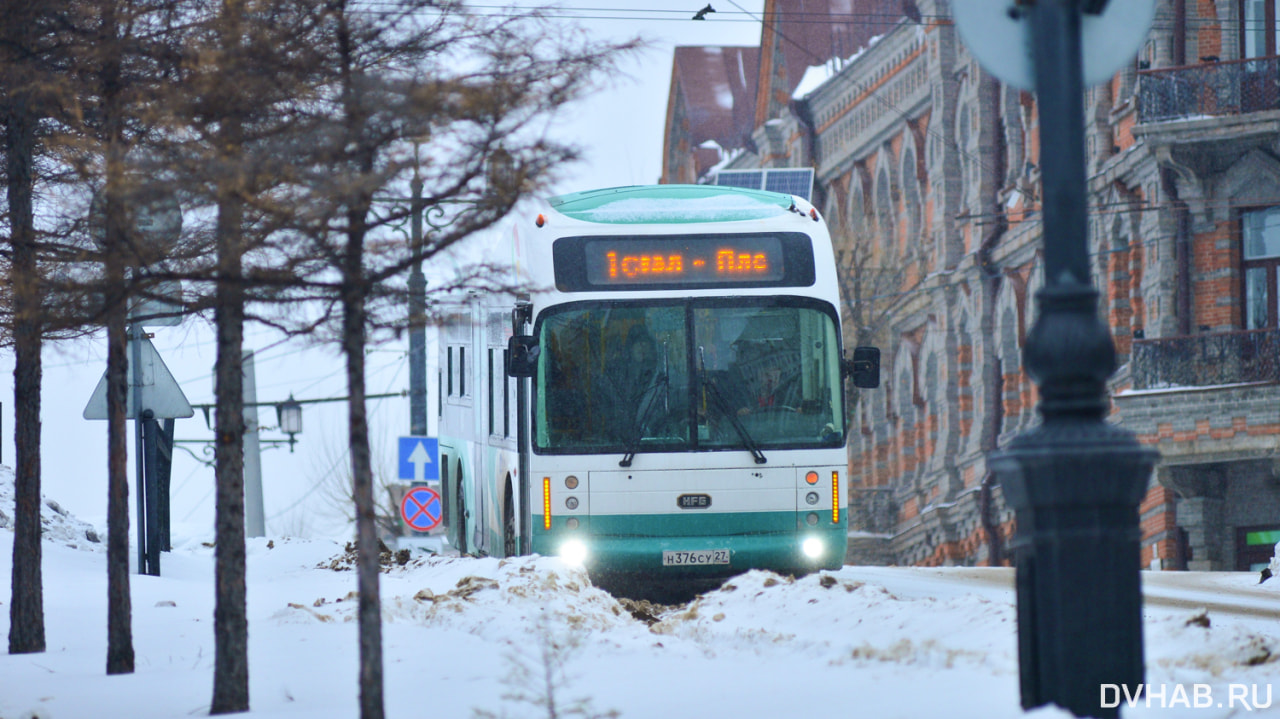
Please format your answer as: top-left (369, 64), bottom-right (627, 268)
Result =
top-left (548, 184), bottom-right (796, 225)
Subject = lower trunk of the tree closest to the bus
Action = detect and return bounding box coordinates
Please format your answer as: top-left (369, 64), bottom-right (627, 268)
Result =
top-left (342, 239), bottom-right (384, 719)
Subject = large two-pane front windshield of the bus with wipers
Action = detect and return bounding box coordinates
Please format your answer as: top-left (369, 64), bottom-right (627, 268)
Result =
top-left (534, 297), bottom-right (845, 455)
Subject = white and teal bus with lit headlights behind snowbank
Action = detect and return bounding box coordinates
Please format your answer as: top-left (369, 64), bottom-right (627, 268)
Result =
top-left (439, 186), bottom-right (879, 581)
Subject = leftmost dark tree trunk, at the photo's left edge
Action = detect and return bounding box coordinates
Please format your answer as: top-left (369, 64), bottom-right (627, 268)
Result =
top-left (5, 88), bottom-right (45, 654)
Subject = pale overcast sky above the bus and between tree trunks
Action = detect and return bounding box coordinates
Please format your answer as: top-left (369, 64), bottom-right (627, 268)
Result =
top-left (0, 0), bottom-right (764, 536)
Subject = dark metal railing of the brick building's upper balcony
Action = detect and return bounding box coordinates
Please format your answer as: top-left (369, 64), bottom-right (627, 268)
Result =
top-left (1138, 58), bottom-right (1280, 123)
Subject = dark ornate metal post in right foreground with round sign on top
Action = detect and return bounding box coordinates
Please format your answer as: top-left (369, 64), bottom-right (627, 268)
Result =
top-left (955, 0), bottom-right (1158, 718)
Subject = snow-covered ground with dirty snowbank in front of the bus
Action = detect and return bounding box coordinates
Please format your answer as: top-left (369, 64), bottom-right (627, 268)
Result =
top-left (0, 470), bottom-right (1280, 719)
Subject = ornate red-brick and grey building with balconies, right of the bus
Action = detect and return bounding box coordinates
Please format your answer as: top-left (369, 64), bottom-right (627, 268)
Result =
top-left (667, 0), bottom-right (1280, 569)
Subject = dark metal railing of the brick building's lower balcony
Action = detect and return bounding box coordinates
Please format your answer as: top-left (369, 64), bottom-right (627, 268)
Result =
top-left (1129, 330), bottom-right (1280, 389)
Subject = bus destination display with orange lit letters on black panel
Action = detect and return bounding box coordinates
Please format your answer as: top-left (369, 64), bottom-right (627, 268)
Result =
top-left (553, 234), bottom-right (813, 290)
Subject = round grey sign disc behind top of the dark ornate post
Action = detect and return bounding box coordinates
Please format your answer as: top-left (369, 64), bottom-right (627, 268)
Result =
top-left (951, 0), bottom-right (1156, 91)
